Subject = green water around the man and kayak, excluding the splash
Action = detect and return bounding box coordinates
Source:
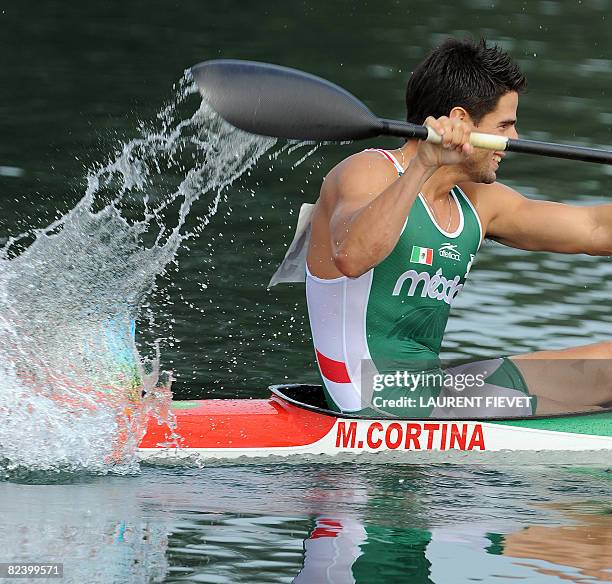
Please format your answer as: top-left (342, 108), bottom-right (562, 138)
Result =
top-left (0, 0), bottom-right (612, 584)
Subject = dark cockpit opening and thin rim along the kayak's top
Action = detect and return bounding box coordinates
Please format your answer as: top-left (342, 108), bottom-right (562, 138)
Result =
top-left (268, 383), bottom-right (612, 422)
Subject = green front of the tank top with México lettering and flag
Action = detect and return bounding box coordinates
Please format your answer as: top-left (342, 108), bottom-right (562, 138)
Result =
top-left (366, 187), bottom-right (482, 369)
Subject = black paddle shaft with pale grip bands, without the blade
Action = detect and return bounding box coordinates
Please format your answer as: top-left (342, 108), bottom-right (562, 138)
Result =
top-left (380, 119), bottom-right (612, 164)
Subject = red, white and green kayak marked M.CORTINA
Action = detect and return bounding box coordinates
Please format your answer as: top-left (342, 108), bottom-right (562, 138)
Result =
top-left (139, 384), bottom-right (612, 461)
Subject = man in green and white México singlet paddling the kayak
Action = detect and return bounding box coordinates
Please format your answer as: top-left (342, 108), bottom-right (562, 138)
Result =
top-left (306, 40), bottom-right (612, 417)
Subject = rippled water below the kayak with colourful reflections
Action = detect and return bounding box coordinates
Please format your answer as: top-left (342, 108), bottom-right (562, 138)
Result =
top-left (0, 464), bottom-right (612, 584)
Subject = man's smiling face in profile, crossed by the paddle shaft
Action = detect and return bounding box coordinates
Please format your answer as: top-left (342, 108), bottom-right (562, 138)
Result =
top-left (464, 91), bottom-right (518, 184)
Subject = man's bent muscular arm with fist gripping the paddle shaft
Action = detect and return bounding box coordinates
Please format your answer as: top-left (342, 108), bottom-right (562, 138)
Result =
top-left (308, 115), bottom-right (474, 279)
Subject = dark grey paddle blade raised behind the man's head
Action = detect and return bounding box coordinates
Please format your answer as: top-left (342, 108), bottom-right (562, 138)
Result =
top-left (191, 59), bottom-right (383, 141)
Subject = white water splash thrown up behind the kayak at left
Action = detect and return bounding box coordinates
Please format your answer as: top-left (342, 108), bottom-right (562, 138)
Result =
top-left (0, 73), bottom-right (275, 476)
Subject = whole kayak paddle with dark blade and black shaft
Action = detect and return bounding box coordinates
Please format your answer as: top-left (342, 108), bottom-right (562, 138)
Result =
top-left (191, 59), bottom-right (612, 164)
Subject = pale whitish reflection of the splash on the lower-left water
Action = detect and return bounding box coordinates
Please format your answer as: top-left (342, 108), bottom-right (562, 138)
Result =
top-left (0, 483), bottom-right (168, 583)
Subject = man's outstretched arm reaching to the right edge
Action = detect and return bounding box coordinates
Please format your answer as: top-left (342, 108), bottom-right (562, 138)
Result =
top-left (478, 183), bottom-right (612, 255)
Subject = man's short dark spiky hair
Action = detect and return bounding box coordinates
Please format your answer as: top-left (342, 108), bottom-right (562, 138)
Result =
top-left (406, 39), bottom-right (527, 124)
